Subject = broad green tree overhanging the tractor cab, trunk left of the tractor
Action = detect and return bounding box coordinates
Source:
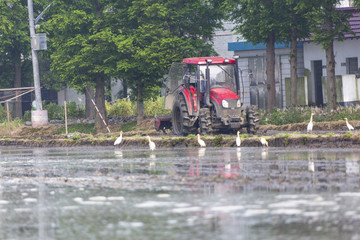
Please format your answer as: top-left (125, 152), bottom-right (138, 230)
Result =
top-left (112, 0), bottom-right (223, 120)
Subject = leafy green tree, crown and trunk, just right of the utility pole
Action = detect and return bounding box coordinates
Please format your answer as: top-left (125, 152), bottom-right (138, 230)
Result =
top-left (43, 0), bottom-right (118, 129)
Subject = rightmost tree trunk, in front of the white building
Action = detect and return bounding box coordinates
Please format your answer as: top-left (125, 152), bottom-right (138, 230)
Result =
top-left (326, 41), bottom-right (336, 109)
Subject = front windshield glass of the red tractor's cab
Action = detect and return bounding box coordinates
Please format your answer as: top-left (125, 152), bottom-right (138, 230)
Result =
top-left (200, 64), bottom-right (236, 92)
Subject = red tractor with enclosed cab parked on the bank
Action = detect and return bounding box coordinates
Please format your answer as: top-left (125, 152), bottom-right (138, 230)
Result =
top-left (155, 57), bottom-right (258, 135)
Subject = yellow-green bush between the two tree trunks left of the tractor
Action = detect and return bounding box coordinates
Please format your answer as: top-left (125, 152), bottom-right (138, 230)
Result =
top-left (105, 98), bottom-right (136, 117)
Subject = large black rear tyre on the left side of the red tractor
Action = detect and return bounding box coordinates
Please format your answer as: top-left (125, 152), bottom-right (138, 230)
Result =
top-left (171, 94), bottom-right (193, 135)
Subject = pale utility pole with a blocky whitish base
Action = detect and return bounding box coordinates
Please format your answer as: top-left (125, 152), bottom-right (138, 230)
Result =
top-left (28, 0), bottom-right (48, 127)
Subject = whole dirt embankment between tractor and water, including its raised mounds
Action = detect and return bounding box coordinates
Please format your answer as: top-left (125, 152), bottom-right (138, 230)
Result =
top-left (0, 119), bottom-right (360, 148)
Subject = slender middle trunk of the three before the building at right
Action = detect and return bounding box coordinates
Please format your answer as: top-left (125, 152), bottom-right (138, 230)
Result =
top-left (290, 13), bottom-right (298, 107)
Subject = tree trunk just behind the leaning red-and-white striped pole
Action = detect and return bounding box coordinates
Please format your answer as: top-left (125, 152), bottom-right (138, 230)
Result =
top-left (95, 76), bottom-right (107, 129)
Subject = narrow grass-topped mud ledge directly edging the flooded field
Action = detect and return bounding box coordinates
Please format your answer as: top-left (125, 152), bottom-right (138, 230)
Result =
top-left (0, 133), bottom-right (360, 148)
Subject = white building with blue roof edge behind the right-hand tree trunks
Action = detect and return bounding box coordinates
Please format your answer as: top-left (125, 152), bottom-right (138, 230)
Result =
top-left (228, 5), bottom-right (360, 108)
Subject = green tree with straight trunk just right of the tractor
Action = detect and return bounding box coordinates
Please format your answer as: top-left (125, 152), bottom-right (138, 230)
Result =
top-left (224, 0), bottom-right (289, 111)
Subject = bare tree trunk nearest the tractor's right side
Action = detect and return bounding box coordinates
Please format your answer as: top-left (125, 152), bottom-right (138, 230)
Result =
top-left (266, 32), bottom-right (276, 112)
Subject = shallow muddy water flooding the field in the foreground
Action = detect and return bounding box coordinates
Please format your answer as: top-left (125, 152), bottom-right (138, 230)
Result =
top-left (0, 147), bottom-right (360, 239)
